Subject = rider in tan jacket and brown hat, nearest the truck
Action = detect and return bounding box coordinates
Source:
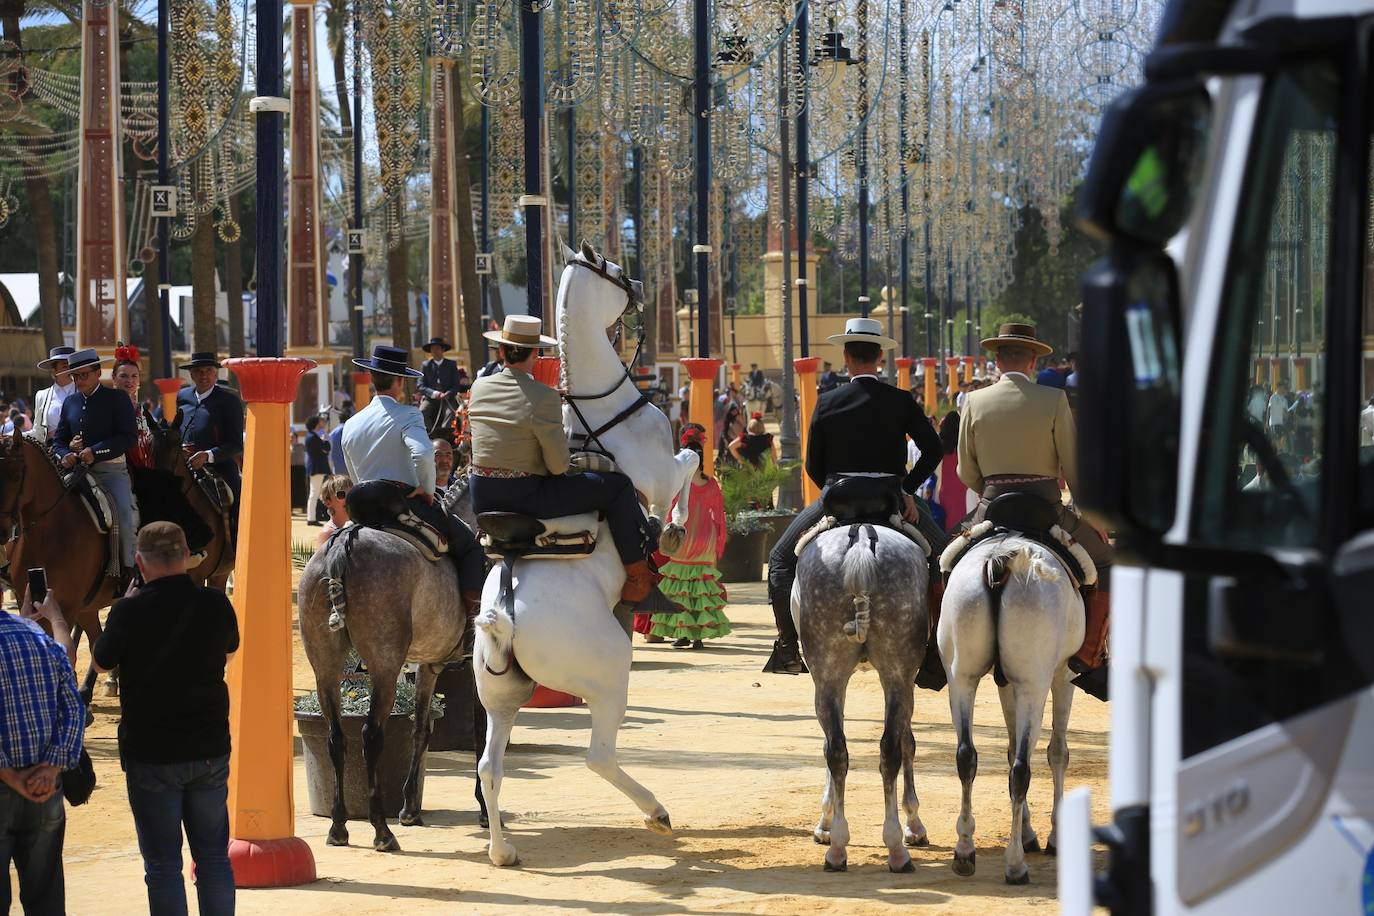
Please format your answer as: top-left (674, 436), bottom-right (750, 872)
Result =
top-left (959, 324), bottom-right (1113, 695)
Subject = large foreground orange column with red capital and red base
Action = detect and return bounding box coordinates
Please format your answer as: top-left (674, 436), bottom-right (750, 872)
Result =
top-left (227, 357), bottom-right (315, 887)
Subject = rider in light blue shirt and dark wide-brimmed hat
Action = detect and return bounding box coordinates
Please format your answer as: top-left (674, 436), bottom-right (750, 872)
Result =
top-left (342, 345), bottom-right (486, 645)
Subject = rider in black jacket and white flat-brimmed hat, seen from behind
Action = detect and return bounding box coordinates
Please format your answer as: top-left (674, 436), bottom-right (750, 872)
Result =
top-left (764, 319), bottom-right (944, 674)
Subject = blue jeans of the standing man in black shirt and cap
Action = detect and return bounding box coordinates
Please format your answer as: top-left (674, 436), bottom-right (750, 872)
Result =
top-left (125, 757), bottom-right (234, 916)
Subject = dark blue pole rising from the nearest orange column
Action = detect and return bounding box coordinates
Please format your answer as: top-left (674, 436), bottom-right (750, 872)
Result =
top-left (256, 0), bottom-right (284, 356)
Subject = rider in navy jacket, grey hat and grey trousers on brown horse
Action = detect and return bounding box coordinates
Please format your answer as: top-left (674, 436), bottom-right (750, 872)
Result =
top-left (52, 350), bottom-right (137, 585)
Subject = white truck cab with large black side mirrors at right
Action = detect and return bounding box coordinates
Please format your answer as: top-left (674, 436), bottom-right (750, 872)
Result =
top-left (1058, 0), bottom-right (1374, 916)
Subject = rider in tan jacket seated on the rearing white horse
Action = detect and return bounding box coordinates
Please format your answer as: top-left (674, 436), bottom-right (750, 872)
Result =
top-left (467, 314), bottom-right (657, 604)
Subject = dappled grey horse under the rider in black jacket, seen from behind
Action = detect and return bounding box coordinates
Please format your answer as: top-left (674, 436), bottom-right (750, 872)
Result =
top-left (791, 525), bottom-right (930, 872)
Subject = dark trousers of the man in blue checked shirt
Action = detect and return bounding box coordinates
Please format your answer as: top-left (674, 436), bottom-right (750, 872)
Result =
top-left (0, 784), bottom-right (67, 916)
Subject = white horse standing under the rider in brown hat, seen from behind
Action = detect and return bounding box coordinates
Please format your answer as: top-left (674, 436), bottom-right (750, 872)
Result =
top-left (936, 534), bottom-right (1084, 884)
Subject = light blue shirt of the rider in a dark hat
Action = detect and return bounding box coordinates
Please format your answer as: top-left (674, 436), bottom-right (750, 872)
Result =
top-left (344, 394), bottom-right (434, 493)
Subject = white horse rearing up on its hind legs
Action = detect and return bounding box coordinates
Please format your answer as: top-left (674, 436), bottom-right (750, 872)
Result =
top-left (473, 242), bottom-right (697, 865)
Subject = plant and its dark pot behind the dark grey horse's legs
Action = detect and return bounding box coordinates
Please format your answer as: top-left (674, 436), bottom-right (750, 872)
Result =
top-left (295, 652), bottom-right (444, 820)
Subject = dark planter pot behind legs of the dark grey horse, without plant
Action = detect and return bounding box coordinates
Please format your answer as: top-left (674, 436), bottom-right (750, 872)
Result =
top-left (295, 713), bottom-right (425, 820)
